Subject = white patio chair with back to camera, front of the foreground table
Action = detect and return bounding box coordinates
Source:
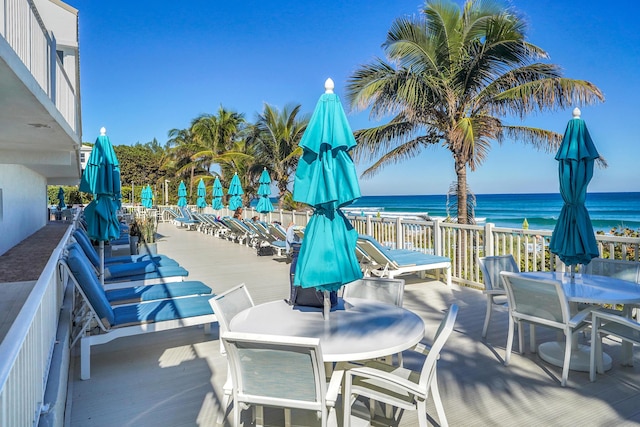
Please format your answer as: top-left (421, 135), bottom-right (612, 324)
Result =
top-left (222, 332), bottom-right (342, 427)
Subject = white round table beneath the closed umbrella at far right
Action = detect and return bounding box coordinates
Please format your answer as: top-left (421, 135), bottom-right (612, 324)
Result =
top-left (520, 271), bottom-right (640, 372)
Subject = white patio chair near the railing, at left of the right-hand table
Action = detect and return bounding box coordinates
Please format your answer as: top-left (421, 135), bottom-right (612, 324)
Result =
top-left (478, 255), bottom-right (520, 338)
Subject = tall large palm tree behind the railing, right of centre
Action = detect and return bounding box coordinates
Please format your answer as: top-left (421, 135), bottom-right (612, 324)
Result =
top-left (347, 0), bottom-right (604, 223)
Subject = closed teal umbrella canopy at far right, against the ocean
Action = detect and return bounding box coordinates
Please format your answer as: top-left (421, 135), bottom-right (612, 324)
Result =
top-left (549, 108), bottom-right (600, 265)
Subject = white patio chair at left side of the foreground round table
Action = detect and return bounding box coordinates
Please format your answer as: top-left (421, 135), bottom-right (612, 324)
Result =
top-left (209, 283), bottom-right (254, 424)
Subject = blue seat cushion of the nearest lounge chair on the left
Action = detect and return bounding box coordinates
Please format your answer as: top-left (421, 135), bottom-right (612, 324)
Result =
top-left (113, 295), bottom-right (213, 326)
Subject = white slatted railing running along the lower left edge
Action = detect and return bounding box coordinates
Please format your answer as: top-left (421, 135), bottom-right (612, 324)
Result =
top-left (0, 225), bottom-right (73, 427)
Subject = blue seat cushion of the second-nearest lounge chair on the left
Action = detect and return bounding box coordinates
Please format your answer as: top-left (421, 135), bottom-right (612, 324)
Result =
top-left (106, 281), bottom-right (211, 304)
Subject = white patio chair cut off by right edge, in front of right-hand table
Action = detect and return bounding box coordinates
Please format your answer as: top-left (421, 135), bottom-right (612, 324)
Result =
top-left (589, 310), bottom-right (640, 381)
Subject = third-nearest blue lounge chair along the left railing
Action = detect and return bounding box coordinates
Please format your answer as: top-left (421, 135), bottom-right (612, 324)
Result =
top-left (67, 243), bottom-right (189, 289)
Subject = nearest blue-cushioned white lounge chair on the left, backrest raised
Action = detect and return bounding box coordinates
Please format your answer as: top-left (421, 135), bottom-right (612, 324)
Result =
top-left (60, 247), bottom-right (217, 380)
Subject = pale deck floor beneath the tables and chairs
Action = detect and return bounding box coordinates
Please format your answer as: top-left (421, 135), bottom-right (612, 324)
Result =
top-left (67, 224), bottom-right (640, 427)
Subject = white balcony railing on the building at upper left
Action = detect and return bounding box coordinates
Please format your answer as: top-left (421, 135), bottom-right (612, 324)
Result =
top-left (0, 0), bottom-right (78, 133)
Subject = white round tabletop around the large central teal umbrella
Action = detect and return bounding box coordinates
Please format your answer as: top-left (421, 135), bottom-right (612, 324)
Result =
top-left (229, 298), bottom-right (425, 362)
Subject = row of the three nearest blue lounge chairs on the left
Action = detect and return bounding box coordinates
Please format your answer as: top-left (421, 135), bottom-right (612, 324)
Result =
top-left (59, 228), bottom-right (217, 380)
